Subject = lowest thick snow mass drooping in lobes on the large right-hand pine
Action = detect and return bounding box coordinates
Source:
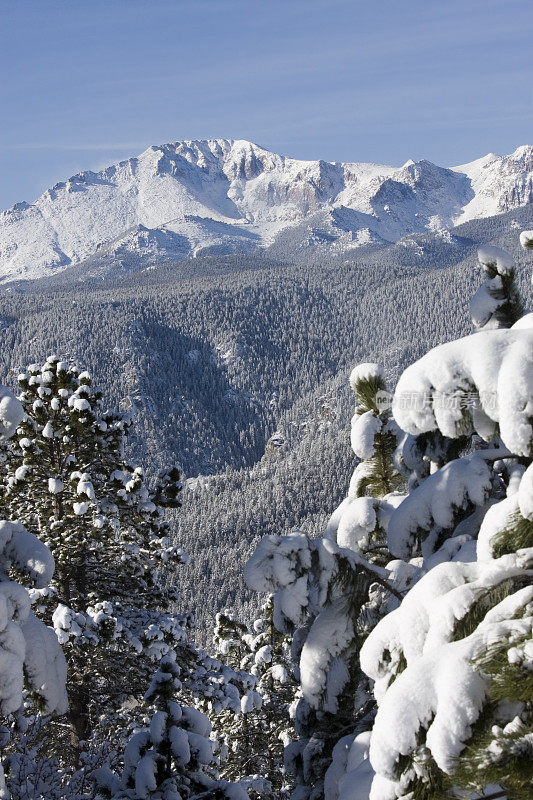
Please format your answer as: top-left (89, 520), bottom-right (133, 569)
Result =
top-left (370, 586), bottom-right (533, 780)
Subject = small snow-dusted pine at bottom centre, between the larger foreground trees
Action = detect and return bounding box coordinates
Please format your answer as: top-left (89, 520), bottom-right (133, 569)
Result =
top-left (213, 598), bottom-right (297, 800)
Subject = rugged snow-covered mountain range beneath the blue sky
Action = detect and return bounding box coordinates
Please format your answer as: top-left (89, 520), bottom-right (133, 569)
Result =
top-left (0, 139), bottom-right (533, 281)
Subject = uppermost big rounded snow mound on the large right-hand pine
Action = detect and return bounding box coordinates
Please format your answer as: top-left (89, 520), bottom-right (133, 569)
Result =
top-left (393, 329), bottom-right (533, 456)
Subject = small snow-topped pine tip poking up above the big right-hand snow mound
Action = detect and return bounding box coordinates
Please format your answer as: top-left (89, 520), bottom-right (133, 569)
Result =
top-left (470, 246), bottom-right (524, 330)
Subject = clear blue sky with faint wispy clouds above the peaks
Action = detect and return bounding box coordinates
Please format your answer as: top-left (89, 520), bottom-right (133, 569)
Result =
top-left (0, 0), bottom-right (533, 208)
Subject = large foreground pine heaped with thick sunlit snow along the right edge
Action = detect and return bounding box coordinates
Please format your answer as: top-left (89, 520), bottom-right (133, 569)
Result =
top-left (332, 230), bottom-right (533, 800)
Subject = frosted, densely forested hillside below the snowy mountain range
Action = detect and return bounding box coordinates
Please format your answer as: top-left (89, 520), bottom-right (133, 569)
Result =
top-left (0, 207), bottom-right (531, 631)
